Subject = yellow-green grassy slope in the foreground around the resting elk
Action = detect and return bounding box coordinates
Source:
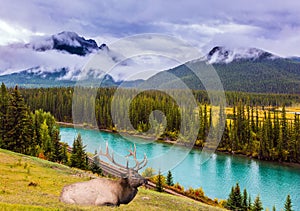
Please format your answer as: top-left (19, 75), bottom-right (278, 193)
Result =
top-left (0, 149), bottom-right (222, 211)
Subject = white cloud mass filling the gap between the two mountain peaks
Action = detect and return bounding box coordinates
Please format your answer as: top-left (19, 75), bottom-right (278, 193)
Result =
top-left (81, 34), bottom-right (202, 80)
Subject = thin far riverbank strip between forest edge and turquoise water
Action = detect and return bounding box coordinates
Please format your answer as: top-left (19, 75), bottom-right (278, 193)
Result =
top-left (57, 122), bottom-right (300, 168)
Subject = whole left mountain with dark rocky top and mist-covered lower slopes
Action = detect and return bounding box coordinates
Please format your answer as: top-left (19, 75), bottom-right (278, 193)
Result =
top-left (0, 32), bottom-right (135, 86)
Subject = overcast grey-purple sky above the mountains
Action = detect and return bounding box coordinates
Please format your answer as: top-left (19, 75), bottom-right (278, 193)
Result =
top-left (0, 0), bottom-right (300, 56)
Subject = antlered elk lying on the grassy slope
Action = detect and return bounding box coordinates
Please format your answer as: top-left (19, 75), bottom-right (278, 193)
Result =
top-left (60, 143), bottom-right (147, 206)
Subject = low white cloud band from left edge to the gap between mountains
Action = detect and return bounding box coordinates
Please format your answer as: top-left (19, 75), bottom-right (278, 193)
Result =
top-left (0, 34), bottom-right (192, 81)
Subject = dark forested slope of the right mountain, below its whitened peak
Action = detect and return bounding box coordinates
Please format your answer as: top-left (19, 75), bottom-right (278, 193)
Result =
top-left (146, 58), bottom-right (300, 94)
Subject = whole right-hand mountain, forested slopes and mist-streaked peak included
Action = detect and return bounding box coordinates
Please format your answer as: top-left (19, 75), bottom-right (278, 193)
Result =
top-left (146, 46), bottom-right (300, 94)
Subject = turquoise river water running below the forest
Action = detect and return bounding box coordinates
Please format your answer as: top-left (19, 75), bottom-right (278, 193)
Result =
top-left (60, 127), bottom-right (300, 211)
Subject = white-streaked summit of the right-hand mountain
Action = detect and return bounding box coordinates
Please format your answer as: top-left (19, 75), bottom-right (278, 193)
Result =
top-left (206, 46), bottom-right (276, 64)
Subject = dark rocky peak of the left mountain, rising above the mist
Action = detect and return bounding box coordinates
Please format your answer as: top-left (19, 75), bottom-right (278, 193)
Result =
top-left (25, 31), bottom-right (99, 56)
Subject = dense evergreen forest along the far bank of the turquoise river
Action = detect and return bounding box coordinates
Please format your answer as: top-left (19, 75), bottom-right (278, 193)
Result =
top-left (10, 84), bottom-right (300, 163)
